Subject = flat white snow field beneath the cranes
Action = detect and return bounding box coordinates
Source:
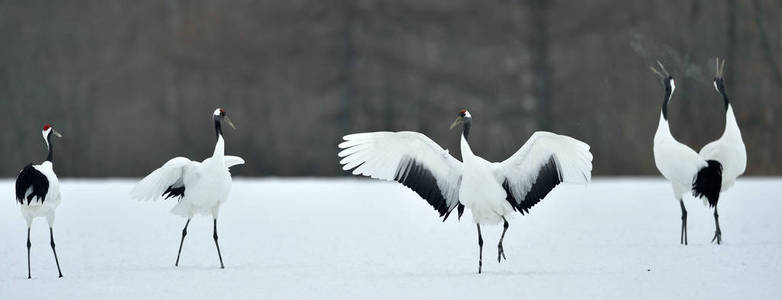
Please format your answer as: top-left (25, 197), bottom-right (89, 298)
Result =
top-left (0, 177), bottom-right (782, 299)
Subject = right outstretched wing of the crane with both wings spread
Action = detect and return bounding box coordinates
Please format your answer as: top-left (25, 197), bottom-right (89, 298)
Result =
top-left (495, 131), bottom-right (592, 214)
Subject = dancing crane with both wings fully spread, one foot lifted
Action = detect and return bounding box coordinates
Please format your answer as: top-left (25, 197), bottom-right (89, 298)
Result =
top-left (339, 110), bottom-right (592, 273)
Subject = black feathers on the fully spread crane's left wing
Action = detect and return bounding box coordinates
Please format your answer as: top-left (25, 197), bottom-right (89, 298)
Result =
top-left (394, 157), bottom-right (453, 220)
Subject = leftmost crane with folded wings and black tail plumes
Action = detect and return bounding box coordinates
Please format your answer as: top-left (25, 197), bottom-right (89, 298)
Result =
top-left (16, 124), bottom-right (62, 279)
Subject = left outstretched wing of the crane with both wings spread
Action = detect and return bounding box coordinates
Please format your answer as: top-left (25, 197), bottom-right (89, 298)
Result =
top-left (339, 131), bottom-right (462, 219)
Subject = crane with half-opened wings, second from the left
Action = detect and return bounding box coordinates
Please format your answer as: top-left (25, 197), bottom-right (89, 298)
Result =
top-left (131, 108), bottom-right (244, 269)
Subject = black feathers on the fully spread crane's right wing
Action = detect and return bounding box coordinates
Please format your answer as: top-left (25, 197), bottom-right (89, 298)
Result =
top-left (502, 155), bottom-right (562, 215)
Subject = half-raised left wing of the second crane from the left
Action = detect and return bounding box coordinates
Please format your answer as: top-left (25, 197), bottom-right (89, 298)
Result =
top-left (130, 157), bottom-right (201, 200)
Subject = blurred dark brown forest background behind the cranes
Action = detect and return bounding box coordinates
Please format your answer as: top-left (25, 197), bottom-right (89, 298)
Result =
top-left (0, 0), bottom-right (782, 177)
